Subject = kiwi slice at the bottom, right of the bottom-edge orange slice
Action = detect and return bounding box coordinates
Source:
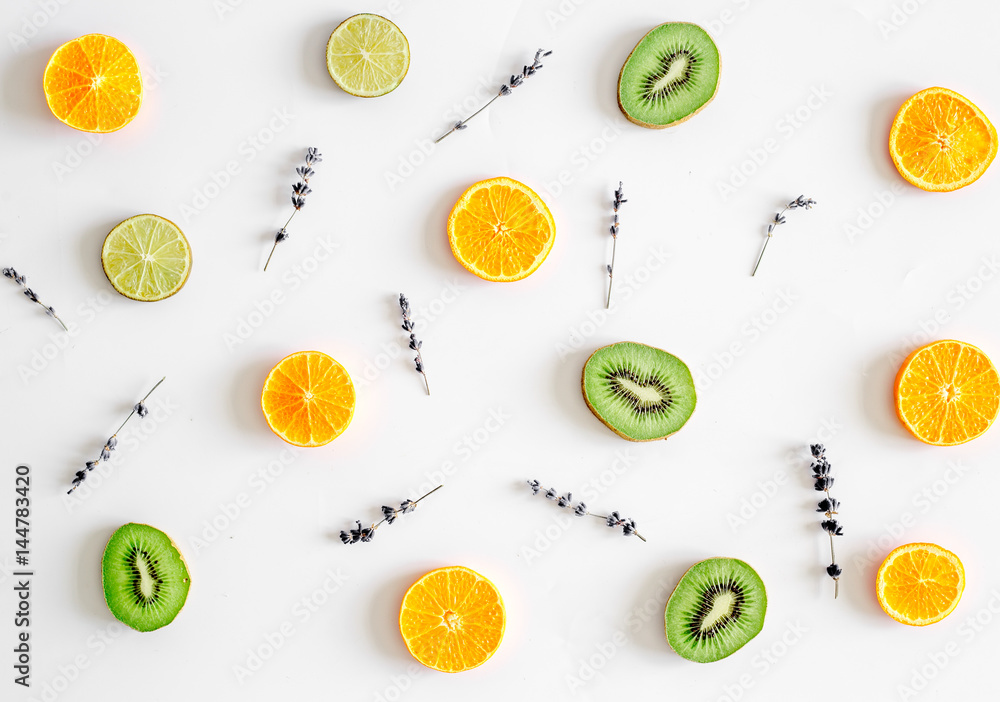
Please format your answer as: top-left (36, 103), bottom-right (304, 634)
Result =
top-left (663, 558), bottom-right (767, 663)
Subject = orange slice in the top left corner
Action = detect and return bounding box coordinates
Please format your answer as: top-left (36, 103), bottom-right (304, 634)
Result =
top-left (43, 34), bottom-right (142, 132)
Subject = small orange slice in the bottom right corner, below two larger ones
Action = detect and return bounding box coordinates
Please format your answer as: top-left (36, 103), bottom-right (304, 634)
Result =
top-left (875, 544), bottom-right (965, 626)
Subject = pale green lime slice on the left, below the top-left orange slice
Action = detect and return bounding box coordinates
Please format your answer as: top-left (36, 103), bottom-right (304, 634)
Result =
top-left (101, 215), bottom-right (191, 302)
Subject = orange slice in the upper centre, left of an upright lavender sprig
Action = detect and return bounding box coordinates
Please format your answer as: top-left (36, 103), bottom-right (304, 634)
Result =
top-left (448, 178), bottom-right (556, 283)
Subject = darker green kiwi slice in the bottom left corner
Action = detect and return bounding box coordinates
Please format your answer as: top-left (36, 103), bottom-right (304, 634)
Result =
top-left (102, 524), bottom-right (191, 631)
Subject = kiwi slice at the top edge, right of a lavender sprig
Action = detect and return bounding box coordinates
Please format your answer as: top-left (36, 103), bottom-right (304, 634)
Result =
top-left (618, 22), bottom-right (720, 129)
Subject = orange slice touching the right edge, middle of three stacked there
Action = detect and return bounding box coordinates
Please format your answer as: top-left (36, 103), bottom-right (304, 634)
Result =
top-left (895, 340), bottom-right (1000, 446)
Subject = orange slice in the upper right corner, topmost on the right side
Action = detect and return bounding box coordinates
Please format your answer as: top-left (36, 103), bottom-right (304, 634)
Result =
top-left (889, 88), bottom-right (997, 192)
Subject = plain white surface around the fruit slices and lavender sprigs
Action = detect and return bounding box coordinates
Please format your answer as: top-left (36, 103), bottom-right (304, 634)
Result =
top-left (0, 0), bottom-right (1000, 701)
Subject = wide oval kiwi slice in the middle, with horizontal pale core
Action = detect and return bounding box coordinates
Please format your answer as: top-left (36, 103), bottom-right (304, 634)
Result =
top-left (583, 341), bottom-right (697, 441)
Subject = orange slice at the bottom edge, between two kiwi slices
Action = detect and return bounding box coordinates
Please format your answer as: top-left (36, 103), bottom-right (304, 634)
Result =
top-left (399, 566), bottom-right (507, 673)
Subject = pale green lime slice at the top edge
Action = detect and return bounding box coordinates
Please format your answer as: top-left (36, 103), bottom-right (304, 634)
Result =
top-left (326, 14), bottom-right (410, 97)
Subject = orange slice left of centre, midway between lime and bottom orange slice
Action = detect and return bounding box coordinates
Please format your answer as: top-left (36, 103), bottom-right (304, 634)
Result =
top-left (260, 351), bottom-right (355, 446)
